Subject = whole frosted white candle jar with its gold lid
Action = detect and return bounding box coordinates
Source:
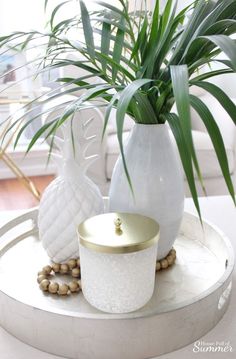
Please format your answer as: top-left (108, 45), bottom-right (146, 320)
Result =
top-left (78, 213), bottom-right (159, 313)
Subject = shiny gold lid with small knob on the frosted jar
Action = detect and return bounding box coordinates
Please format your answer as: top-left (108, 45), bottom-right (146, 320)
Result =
top-left (78, 213), bottom-right (160, 253)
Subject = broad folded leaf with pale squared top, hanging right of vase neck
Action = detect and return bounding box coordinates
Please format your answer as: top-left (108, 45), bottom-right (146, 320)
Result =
top-left (170, 65), bottom-right (205, 192)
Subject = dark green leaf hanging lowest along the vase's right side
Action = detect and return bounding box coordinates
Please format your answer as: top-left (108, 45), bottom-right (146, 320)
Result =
top-left (163, 113), bottom-right (202, 221)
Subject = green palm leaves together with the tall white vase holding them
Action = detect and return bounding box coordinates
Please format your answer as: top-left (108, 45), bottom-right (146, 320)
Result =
top-left (1, 0), bottom-right (236, 258)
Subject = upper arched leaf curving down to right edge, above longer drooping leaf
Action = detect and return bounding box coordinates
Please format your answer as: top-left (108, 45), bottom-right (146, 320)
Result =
top-left (191, 81), bottom-right (236, 125)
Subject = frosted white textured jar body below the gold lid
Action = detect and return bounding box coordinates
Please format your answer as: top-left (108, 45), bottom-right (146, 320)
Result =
top-left (80, 243), bottom-right (157, 313)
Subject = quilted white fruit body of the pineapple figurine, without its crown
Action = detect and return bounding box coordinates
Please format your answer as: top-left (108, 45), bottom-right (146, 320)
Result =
top-left (39, 175), bottom-right (103, 263)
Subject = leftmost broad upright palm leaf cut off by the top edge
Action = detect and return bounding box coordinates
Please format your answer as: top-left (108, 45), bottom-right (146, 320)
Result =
top-left (79, 0), bottom-right (95, 59)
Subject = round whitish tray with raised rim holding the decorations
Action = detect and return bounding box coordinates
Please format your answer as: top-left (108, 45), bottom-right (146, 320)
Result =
top-left (0, 209), bottom-right (234, 359)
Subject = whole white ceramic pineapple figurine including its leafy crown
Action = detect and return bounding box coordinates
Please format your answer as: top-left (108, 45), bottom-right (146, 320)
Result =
top-left (38, 119), bottom-right (104, 263)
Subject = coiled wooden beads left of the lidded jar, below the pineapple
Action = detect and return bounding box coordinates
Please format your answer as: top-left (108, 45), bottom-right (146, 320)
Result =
top-left (37, 259), bottom-right (81, 296)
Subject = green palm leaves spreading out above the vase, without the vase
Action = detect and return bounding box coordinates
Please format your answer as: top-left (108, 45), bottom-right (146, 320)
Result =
top-left (0, 0), bottom-right (236, 214)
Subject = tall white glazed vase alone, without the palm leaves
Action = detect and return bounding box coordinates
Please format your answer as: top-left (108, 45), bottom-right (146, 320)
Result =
top-left (109, 124), bottom-right (184, 259)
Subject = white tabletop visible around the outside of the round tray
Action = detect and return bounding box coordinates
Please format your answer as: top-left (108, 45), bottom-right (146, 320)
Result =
top-left (0, 197), bottom-right (236, 359)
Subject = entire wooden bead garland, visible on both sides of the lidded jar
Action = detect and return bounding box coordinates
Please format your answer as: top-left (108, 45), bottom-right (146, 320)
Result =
top-left (37, 248), bottom-right (176, 296)
